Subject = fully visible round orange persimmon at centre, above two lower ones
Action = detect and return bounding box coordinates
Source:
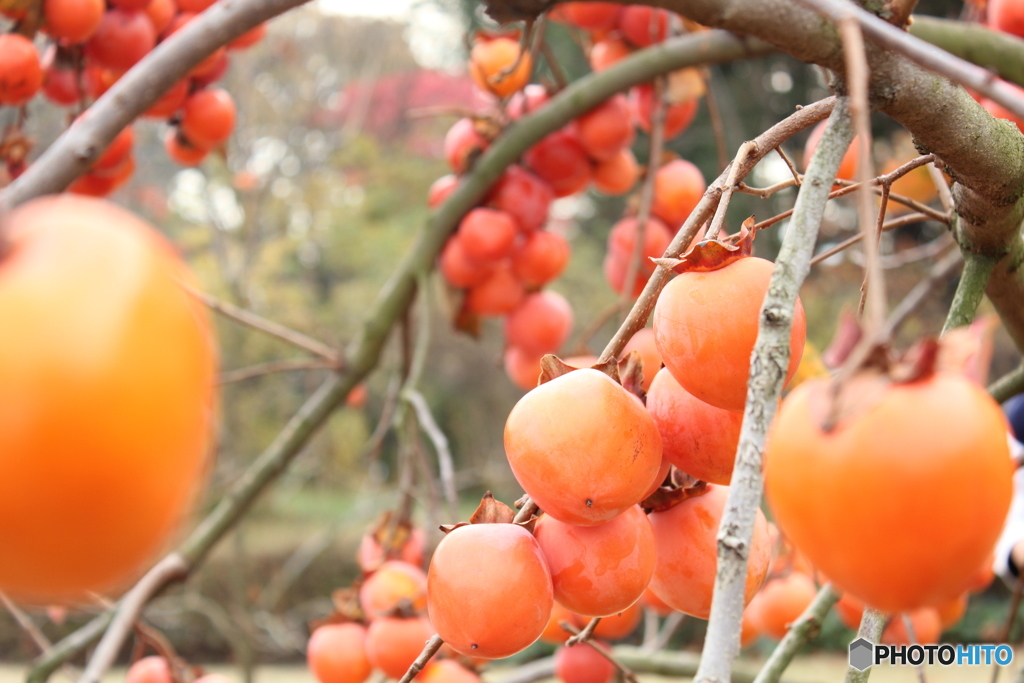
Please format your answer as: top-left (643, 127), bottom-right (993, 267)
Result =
top-left (505, 369), bottom-right (662, 526)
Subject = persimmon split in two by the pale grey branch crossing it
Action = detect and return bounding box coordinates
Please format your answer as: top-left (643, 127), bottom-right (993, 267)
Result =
top-left (648, 484), bottom-right (771, 618)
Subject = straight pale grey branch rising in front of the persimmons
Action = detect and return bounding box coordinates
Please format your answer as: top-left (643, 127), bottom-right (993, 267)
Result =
top-left (694, 99), bottom-right (853, 683)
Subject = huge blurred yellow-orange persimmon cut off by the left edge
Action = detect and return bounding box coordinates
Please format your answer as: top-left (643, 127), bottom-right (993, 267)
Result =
top-left (0, 196), bottom-right (217, 602)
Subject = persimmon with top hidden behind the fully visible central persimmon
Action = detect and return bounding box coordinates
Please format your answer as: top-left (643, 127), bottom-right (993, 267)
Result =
top-left (534, 505), bottom-right (655, 616)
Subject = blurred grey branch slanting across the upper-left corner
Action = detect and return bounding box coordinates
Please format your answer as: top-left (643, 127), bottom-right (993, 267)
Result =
top-left (0, 0), bottom-right (307, 214)
